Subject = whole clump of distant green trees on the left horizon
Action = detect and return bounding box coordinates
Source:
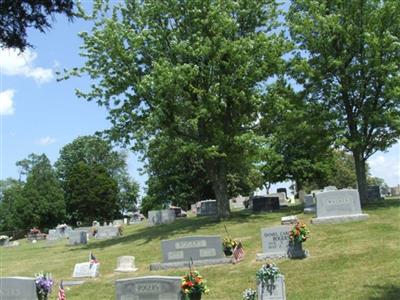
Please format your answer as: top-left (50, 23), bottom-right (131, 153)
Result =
top-left (0, 136), bottom-right (139, 231)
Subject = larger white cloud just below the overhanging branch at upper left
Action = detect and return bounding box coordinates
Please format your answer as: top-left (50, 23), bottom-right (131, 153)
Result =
top-left (0, 49), bottom-right (53, 83)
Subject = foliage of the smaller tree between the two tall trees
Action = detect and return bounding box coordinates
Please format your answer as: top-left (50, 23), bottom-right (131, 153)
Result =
top-left (261, 80), bottom-right (335, 191)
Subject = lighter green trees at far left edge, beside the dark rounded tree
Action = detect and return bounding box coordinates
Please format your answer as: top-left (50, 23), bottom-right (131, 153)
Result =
top-left (0, 154), bottom-right (66, 230)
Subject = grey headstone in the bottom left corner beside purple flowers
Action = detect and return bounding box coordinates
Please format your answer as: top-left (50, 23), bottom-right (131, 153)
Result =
top-left (0, 277), bottom-right (37, 300)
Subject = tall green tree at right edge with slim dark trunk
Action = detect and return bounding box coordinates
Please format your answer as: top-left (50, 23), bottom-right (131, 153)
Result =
top-left (287, 0), bottom-right (400, 202)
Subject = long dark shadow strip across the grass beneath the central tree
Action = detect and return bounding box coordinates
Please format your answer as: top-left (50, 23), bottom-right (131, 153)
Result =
top-left (70, 205), bottom-right (302, 251)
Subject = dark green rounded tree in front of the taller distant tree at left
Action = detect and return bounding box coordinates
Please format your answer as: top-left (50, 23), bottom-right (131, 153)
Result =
top-left (64, 162), bottom-right (118, 224)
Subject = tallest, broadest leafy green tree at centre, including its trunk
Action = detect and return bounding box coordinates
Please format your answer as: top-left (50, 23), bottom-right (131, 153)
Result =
top-left (67, 0), bottom-right (286, 217)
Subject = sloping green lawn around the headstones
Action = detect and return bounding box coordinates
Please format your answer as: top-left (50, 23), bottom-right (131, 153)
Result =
top-left (0, 199), bottom-right (400, 300)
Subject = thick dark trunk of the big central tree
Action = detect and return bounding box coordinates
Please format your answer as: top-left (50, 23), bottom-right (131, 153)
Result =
top-left (208, 160), bottom-right (230, 219)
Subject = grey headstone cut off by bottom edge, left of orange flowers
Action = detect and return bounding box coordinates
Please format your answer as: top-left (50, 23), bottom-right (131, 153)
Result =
top-left (115, 276), bottom-right (182, 300)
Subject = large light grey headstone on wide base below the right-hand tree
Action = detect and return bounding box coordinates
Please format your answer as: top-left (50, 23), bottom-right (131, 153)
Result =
top-left (311, 189), bottom-right (368, 224)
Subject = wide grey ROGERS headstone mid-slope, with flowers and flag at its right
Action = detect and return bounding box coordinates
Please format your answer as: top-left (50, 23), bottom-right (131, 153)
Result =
top-left (150, 236), bottom-right (231, 270)
